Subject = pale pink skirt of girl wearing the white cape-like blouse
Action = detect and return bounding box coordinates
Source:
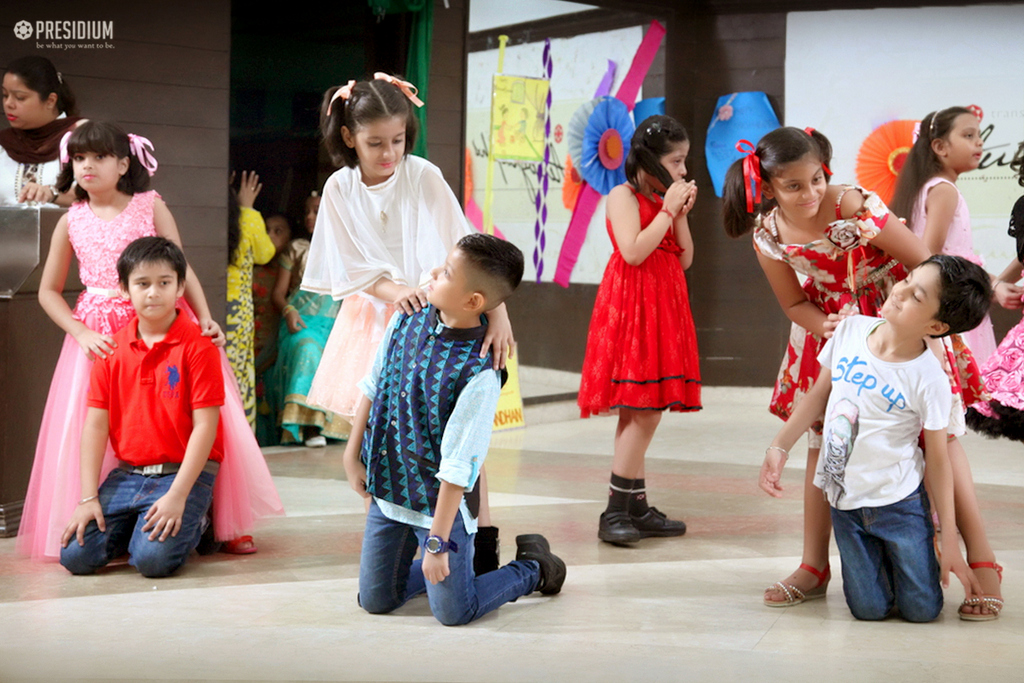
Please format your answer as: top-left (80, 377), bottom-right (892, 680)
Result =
top-left (307, 295), bottom-right (395, 419)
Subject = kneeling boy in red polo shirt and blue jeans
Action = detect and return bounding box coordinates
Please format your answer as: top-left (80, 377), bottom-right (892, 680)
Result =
top-left (60, 237), bottom-right (224, 578)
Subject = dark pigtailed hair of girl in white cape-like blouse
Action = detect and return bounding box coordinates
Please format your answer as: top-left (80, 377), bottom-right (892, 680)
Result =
top-left (321, 79), bottom-right (419, 168)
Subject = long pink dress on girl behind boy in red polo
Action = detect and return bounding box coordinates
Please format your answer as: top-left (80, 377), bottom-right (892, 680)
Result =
top-left (17, 191), bottom-right (284, 559)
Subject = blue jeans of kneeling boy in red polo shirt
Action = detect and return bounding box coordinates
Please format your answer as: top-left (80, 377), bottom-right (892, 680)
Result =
top-left (60, 469), bottom-right (216, 579)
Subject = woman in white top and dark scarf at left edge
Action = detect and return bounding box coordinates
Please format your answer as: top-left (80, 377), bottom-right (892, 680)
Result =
top-left (0, 55), bottom-right (80, 206)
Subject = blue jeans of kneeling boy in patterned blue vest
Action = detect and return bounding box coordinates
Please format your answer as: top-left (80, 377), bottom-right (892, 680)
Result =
top-left (359, 501), bottom-right (541, 626)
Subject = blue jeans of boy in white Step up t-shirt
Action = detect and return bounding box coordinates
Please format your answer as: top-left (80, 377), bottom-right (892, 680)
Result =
top-left (831, 484), bottom-right (937, 622)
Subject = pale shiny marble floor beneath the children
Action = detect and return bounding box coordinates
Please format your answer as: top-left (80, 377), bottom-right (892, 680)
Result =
top-left (0, 382), bottom-right (1024, 683)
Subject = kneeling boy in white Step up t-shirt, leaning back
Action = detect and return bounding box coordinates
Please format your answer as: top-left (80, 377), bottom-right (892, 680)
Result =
top-left (760, 255), bottom-right (992, 622)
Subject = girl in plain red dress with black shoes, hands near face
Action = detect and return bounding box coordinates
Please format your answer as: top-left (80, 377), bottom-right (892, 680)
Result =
top-left (578, 116), bottom-right (700, 545)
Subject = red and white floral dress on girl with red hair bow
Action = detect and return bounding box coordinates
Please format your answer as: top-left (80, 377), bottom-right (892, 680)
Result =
top-left (754, 185), bottom-right (983, 447)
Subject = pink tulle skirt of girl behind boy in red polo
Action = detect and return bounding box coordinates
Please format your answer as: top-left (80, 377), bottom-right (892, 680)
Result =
top-left (17, 294), bottom-right (284, 560)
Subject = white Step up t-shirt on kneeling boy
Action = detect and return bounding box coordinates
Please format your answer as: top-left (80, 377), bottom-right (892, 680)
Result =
top-left (814, 315), bottom-right (952, 510)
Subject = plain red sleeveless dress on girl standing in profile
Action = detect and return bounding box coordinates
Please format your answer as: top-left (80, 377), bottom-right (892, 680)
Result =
top-left (578, 184), bottom-right (700, 418)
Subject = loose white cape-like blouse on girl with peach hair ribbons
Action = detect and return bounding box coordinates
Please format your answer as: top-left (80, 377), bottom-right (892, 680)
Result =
top-left (302, 156), bottom-right (472, 299)
